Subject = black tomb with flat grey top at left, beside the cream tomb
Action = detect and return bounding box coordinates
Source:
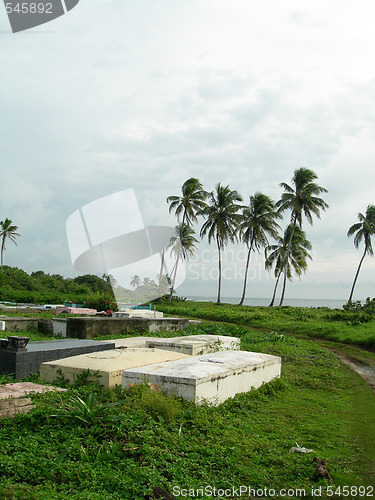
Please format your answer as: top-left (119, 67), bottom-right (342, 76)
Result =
top-left (0, 337), bottom-right (115, 380)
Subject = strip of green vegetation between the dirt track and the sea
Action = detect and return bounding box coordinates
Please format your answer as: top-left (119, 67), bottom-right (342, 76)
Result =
top-left (157, 299), bottom-right (375, 350)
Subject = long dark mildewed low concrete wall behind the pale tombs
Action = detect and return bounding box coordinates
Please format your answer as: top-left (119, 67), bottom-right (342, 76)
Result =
top-left (56, 318), bottom-right (189, 339)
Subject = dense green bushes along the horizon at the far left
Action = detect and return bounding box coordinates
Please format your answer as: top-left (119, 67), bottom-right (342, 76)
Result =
top-left (0, 266), bottom-right (113, 304)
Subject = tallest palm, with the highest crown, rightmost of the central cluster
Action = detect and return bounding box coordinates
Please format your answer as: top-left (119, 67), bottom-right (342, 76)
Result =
top-left (276, 167), bottom-right (328, 306)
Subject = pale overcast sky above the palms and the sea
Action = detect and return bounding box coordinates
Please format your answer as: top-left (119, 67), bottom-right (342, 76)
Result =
top-left (0, 0), bottom-right (375, 300)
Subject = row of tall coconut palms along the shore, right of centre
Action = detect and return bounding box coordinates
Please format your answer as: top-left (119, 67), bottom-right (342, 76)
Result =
top-left (166, 171), bottom-right (375, 306)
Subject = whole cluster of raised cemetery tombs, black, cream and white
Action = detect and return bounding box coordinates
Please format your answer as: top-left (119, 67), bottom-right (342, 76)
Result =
top-left (0, 311), bottom-right (281, 404)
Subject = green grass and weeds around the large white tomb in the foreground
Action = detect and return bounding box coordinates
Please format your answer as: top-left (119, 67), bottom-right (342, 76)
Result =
top-left (0, 324), bottom-right (375, 500)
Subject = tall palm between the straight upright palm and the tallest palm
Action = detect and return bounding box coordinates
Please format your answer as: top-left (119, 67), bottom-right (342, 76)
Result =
top-left (238, 192), bottom-right (280, 306)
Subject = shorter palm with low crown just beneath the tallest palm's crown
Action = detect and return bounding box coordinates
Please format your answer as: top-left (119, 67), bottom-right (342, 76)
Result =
top-left (265, 224), bottom-right (312, 307)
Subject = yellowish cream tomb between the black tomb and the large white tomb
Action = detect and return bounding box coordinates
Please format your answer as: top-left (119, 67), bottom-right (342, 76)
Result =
top-left (40, 348), bottom-right (191, 387)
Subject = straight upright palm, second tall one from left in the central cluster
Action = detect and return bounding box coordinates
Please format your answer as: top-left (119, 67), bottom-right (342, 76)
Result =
top-left (199, 183), bottom-right (243, 304)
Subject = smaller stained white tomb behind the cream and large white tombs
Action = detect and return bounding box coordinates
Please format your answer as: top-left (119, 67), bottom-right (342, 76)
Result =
top-left (146, 335), bottom-right (241, 356)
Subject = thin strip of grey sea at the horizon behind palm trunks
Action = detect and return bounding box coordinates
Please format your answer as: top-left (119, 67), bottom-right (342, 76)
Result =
top-left (186, 296), bottom-right (346, 309)
